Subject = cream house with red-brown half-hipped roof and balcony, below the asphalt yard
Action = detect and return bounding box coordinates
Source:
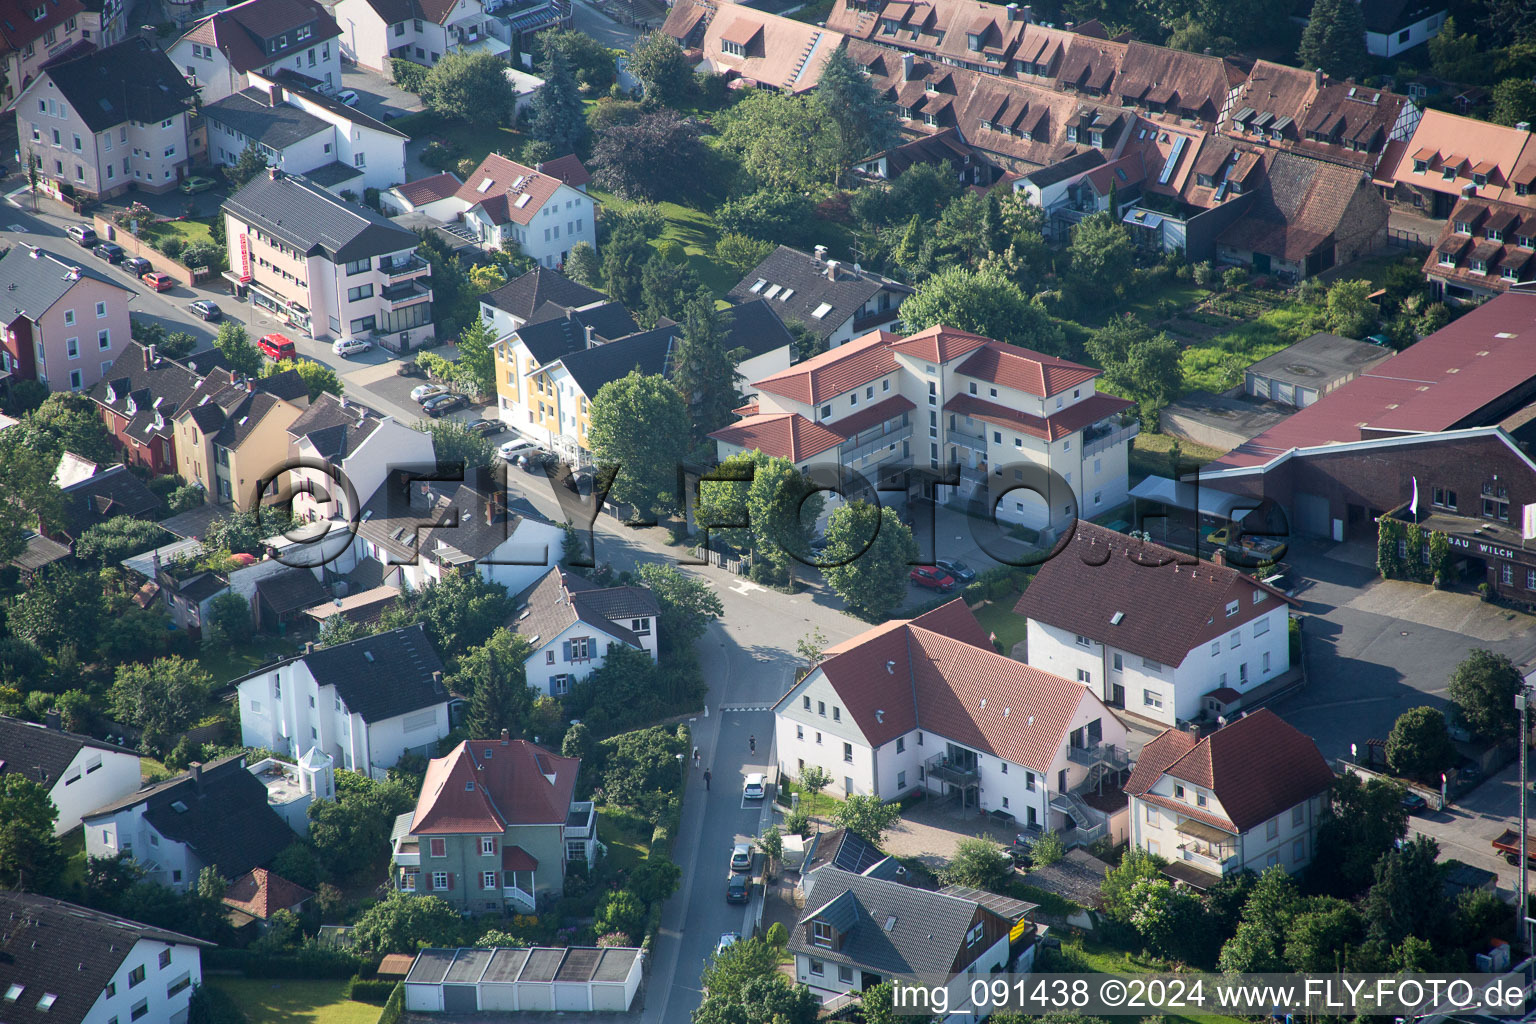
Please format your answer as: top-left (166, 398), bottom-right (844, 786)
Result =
top-left (1126, 708), bottom-right (1333, 889)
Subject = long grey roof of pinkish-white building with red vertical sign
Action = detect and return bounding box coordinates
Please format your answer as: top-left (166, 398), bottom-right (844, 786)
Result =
top-left (224, 172), bottom-right (421, 263)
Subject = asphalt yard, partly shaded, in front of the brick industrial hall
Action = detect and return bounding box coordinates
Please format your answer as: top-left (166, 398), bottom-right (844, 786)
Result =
top-left (1273, 540), bottom-right (1536, 757)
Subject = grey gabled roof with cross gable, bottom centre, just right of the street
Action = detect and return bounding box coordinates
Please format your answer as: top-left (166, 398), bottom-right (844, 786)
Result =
top-left (790, 867), bottom-right (995, 981)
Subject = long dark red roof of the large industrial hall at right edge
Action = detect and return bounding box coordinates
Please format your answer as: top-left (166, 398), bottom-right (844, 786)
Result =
top-left (1206, 292), bottom-right (1536, 470)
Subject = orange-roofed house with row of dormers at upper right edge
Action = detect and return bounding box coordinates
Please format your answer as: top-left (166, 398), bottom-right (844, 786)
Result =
top-left (1382, 109), bottom-right (1536, 220)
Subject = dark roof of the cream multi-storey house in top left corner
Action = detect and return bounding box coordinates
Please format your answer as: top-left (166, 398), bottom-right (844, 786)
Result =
top-left (46, 35), bottom-right (194, 132)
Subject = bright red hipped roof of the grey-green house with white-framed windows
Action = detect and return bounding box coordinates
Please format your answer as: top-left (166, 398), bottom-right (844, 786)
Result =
top-left (410, 740), bottom-right (581, 835)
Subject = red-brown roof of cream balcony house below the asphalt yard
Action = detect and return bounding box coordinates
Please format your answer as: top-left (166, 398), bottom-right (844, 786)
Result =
top-left (1126, 708), bottom-right (1333, 832)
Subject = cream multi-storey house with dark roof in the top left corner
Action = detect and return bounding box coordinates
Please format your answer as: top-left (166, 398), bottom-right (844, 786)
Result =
top-left (15, 37), bottom-right (192, 200)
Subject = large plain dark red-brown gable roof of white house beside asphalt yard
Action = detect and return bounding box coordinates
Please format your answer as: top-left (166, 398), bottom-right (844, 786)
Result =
top-left (1014, 519), bottom-right (1290, 668)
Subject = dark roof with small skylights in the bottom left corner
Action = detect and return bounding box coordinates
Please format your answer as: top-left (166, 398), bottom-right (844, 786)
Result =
top-left (0, 890), bottom-right (212, 1024)
